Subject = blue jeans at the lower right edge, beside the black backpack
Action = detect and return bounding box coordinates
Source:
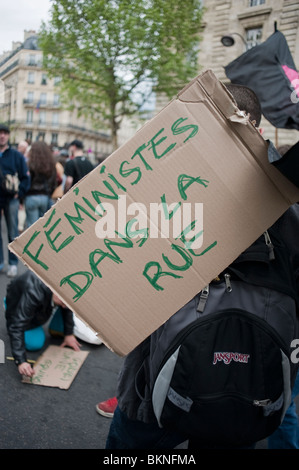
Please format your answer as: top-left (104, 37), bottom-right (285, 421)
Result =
top-left (268, 373), bottom-right (299, 449)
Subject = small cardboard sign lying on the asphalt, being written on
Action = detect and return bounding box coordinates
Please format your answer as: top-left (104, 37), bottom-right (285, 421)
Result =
top-left (22, 346), bottom-right (89, 390)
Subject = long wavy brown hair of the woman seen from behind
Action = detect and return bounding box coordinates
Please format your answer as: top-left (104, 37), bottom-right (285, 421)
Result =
top-left (28, 141), bottom-right (55, 177)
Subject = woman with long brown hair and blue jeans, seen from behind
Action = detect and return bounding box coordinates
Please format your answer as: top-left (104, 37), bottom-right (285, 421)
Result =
top-left (25, 141), bottom-right (56, 227)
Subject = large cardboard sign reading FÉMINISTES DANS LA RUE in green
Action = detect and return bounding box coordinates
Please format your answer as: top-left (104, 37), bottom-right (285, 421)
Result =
top-left (9, 70), bottom-right (299, 355)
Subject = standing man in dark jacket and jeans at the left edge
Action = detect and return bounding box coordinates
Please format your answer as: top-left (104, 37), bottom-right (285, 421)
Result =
top-left (0, 124), bottom-right (30, 277)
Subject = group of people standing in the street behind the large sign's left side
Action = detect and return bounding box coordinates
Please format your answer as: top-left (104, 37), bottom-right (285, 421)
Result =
top-left (0, 124), bottom-right (94, 277)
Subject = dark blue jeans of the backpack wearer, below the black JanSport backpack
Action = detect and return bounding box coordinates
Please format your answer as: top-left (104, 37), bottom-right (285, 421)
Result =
top-left (106, 407), bottom-right (187, 449)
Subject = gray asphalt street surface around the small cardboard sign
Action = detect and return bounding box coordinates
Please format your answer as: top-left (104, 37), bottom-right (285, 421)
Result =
top-left (0, 224), bottom-right (298, 449)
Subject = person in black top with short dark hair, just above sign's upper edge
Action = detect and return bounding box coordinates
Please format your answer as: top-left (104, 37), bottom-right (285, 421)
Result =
top-left (64, 140), bottom-right (94, 193)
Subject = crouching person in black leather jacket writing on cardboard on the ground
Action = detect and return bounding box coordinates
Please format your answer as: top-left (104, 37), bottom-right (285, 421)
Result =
top-left (5, 270), bottom-right (80, 377)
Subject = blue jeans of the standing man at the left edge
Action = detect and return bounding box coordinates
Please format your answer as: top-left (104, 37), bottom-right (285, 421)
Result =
top-left (0, 199), bottom-right (20, 266)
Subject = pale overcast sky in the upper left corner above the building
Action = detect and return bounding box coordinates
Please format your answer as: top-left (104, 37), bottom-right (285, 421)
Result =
top-left (0, 0), bottom-right (51, 55)
